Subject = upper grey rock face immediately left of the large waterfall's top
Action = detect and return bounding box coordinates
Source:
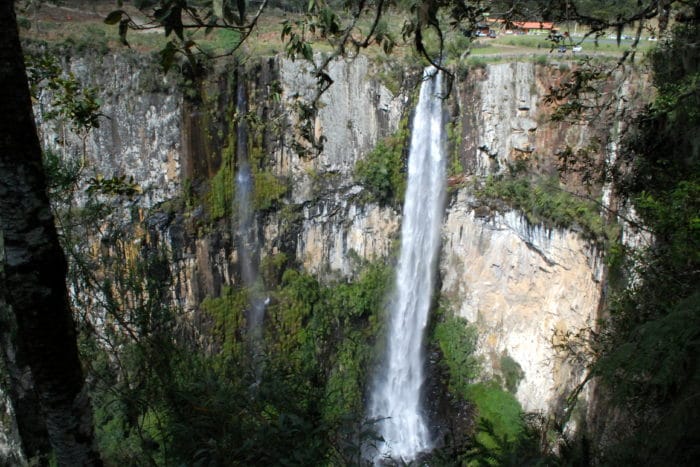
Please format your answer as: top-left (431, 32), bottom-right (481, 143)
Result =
top-left (277, 57), bottom-right (407, 203)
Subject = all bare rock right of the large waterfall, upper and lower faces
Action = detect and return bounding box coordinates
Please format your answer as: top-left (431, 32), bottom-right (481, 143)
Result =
top-left (440, 62), bottom-right (648, 412)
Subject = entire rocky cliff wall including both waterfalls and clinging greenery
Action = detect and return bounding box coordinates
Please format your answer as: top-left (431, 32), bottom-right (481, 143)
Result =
top-left (0, 3), bottom-right (684, 465)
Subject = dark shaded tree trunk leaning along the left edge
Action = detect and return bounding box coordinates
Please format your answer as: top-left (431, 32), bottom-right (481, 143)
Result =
top-left (0, 0), bottom-right (101, 466)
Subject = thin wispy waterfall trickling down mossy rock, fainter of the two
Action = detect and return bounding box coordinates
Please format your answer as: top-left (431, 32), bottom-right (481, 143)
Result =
top-left (234, 77), bottom-right (265, 357)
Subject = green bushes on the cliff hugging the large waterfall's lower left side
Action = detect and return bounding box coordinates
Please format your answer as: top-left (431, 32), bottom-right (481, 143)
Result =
top-left (270, 264), bottom-right (391, 426)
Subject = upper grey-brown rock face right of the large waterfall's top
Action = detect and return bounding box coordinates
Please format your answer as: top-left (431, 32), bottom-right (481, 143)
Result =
top-left (452, 62), bottom-right (592, 177)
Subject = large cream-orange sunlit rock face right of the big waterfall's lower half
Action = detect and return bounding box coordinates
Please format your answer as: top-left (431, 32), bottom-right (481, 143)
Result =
top-left (441, 191), bottom-right (602, 412)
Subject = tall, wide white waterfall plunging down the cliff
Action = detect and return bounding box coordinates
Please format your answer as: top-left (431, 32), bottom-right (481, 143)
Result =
top-left (368, 68), bottom-right (445, 464)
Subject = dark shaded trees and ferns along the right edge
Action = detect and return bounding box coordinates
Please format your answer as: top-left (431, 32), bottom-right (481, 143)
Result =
top-left (593, 2), bottom-right (700, 465)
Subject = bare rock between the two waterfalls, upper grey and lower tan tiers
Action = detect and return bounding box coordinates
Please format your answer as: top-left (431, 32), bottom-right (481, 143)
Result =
top-left (264, 57), bottom-right (407, 277)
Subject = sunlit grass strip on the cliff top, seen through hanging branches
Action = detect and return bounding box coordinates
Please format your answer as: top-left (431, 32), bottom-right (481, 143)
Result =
top-left (19, 2), bottom-right (653, 63)
